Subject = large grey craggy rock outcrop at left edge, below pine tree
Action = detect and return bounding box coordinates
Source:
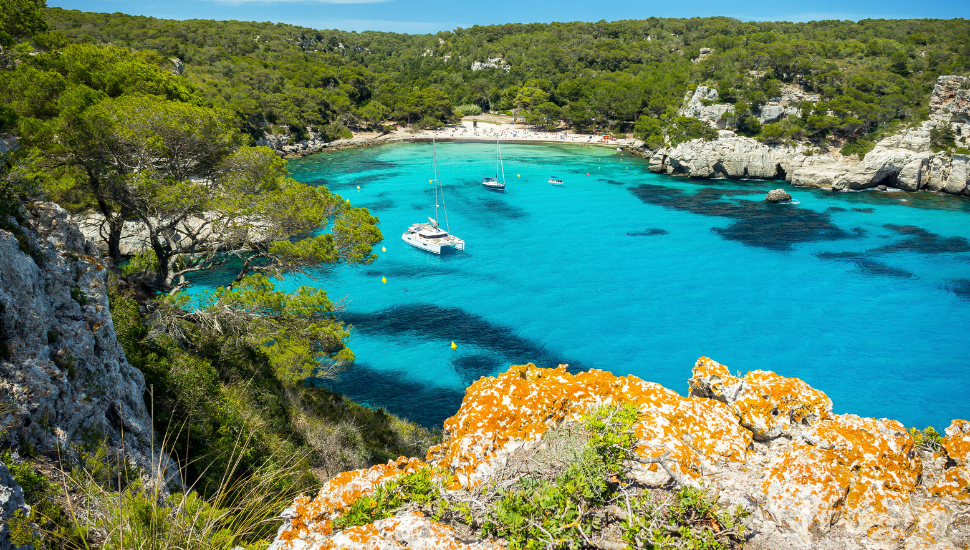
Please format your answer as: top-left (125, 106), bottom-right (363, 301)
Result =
top-left (0, 203), bottom-right (175, 484)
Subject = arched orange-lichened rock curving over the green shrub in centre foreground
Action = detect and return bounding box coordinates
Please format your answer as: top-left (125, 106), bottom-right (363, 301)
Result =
top-left (428, 364), bottom-right (751, 485)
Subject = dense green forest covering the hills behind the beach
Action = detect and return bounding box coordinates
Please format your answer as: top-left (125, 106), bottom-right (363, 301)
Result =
top-left (28, 9), bottom-right (970, 152)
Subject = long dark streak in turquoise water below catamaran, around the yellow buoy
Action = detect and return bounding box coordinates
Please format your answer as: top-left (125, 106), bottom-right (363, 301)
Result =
top-left (340, 304), bottom-right (584, 372)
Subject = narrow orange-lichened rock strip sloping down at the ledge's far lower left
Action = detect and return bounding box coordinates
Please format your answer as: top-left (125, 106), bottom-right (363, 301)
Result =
top-left (274, 456), bottom-right (424, 550)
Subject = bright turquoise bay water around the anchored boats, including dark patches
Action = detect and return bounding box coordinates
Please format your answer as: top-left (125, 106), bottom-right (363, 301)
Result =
top-left (212, 143), bottom-right (970, 436)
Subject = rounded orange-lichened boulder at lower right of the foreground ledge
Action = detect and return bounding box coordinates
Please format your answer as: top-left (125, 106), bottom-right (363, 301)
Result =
top-left (762, 415), bottom-right (922, 539)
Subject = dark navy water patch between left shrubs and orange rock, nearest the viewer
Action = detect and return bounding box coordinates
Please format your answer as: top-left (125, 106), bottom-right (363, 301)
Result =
top-left (313, 362), bottom-right (465, 428)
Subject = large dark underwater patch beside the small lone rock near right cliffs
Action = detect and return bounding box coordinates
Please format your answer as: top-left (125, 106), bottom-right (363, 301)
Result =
top-left (630, 184), bottom-right (854, 250)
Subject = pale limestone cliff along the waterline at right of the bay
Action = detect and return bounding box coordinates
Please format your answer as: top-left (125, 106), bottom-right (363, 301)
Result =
top-left (650, 76), bottom-right (970, 195)
